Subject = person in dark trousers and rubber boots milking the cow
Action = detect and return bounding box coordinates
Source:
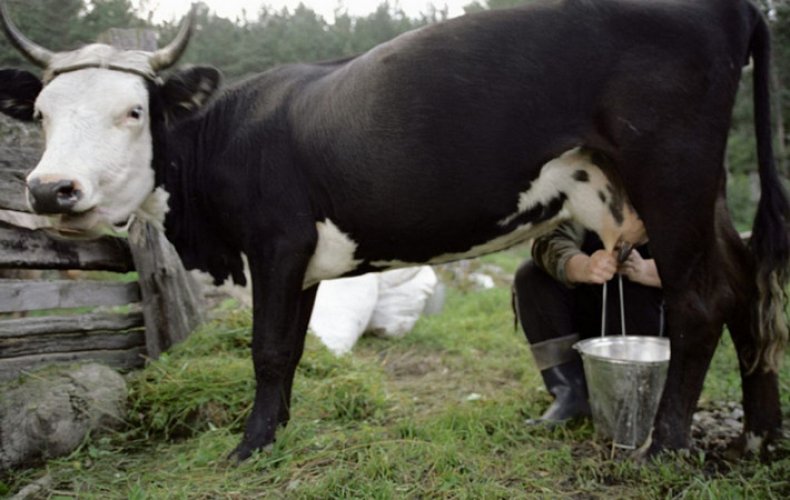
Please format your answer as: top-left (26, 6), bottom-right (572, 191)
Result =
top-left (513, 221), bottom-right (663, 423)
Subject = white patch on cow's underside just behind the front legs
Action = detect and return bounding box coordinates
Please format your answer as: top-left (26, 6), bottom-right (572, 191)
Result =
top-left (302, 219), bottom-right (362, 288)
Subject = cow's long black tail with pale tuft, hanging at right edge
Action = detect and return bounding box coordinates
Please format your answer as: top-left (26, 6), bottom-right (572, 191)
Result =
top-left (749, 14), bottom-right (790, 371)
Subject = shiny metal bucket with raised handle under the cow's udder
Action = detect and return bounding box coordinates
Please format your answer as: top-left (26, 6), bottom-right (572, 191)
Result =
top-left (573, 275), bottom-right (670, 449)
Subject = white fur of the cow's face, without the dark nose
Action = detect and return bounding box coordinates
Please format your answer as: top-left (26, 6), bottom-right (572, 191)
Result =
top-left (28, 68), bottom-right (154, 233)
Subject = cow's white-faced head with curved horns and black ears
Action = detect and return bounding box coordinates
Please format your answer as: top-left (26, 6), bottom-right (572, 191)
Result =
top-left (0, 0), bottom-right (220, 236)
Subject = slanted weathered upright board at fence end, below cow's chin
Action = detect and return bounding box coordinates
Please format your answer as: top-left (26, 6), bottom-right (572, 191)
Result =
top-left (129, 221), bottom-right (203, 359)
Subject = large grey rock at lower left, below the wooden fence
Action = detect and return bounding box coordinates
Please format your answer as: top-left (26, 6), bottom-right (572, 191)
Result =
top-left (0, 363), bottom-right (127, 470)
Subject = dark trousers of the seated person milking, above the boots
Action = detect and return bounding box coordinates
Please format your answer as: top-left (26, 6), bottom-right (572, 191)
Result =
top-left (513, 261), bottom-right (663, 345)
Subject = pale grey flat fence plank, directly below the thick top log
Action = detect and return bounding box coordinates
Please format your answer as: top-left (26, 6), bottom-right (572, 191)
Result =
top-left (0, 280), bottom-right (140, 312)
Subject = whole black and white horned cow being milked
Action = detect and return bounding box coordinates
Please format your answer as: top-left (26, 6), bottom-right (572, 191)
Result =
top-left (0, 0), bottom-right (790, 459)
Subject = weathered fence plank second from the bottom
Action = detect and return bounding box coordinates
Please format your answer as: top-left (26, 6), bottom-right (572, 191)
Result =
top-left (0, 328), bottom-right (145, 359)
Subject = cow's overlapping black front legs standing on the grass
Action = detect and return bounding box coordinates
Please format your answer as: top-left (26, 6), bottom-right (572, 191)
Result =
top-left (231, 240), bottom-right (316, 460)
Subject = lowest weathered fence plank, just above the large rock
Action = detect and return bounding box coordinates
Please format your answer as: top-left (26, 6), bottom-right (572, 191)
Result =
top-left (0, 347), bottom-right (146, 381)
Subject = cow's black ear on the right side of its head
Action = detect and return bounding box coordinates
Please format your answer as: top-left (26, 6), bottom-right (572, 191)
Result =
top-left (162, 66), bottom-right (222, 120)
